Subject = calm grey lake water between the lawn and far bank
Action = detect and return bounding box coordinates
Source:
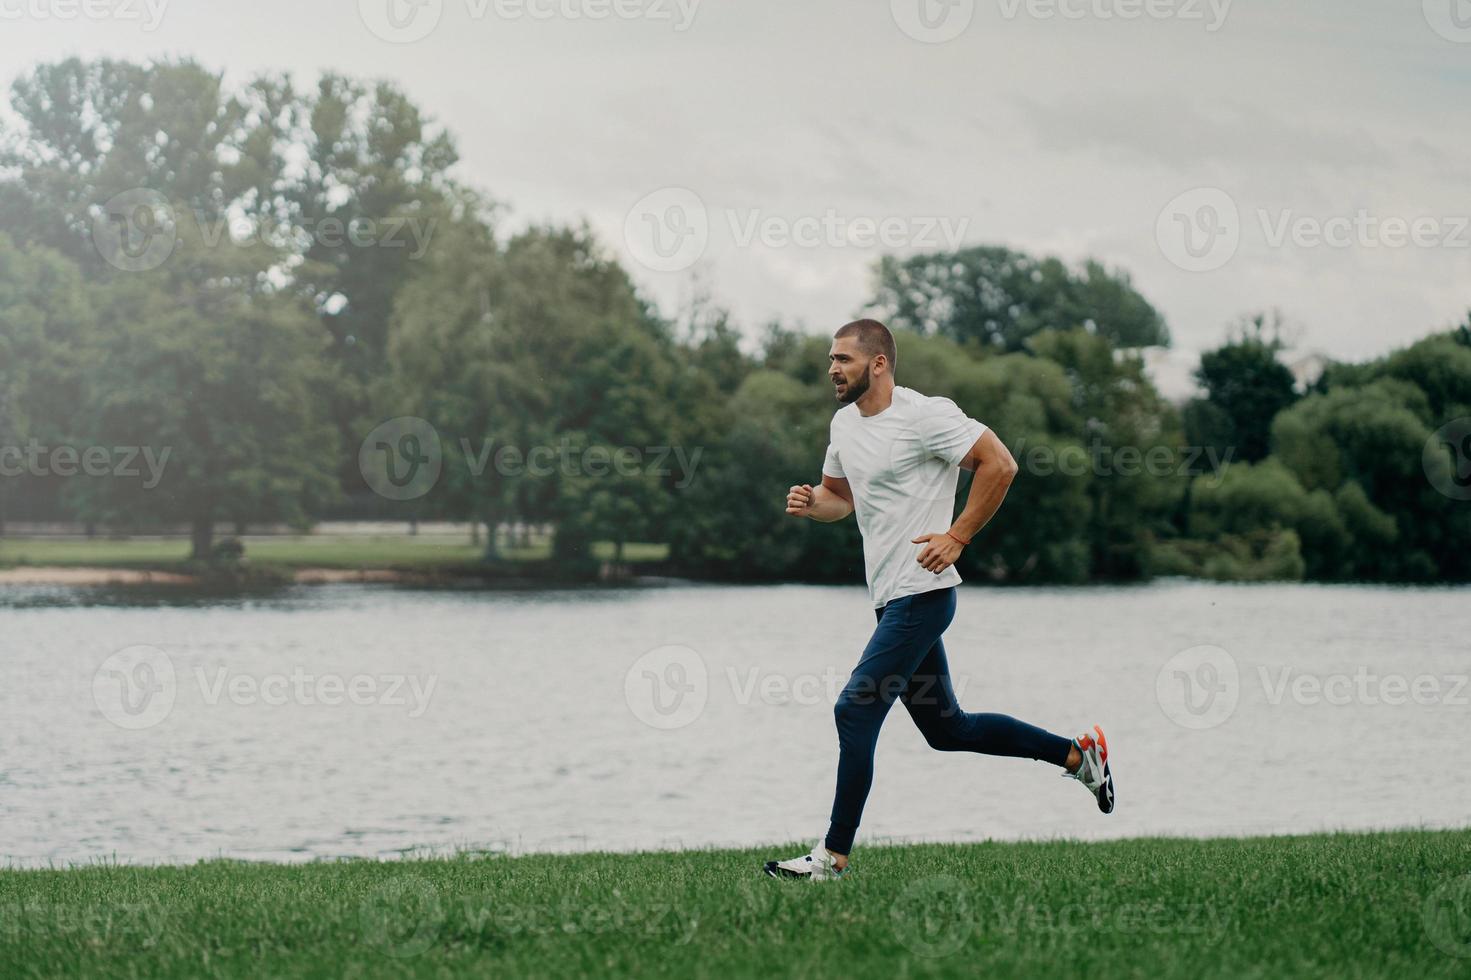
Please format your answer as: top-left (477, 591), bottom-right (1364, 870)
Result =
top-left (0, 583), bottom-right (1471, 867)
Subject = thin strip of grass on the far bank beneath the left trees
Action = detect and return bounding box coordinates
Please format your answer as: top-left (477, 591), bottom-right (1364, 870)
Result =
top-left (0, 534), bottom-right (669, 569)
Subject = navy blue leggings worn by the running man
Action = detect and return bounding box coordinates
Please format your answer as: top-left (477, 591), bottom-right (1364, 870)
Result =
top-left (825, 586), bottom-right (1072, 853)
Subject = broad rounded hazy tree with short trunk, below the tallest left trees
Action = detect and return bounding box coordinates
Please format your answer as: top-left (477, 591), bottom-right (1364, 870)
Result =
top-left (74, 224), bottom-right (338, 559)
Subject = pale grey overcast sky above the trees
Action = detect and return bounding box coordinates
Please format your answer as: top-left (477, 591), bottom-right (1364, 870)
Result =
top-left (0, 0), bottom-right (1471, 358)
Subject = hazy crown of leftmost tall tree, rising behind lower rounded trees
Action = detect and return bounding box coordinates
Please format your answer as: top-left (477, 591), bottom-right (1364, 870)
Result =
top-left (0, 57), bottom-right (293, 270)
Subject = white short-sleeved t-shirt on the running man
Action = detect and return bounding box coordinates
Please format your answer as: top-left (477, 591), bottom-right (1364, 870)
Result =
top-left (822, 386), bottom-right (986, 609)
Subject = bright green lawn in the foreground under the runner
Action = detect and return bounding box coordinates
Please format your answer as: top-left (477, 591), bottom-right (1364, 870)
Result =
top-left (0, 831), bottom-right (1471, 980)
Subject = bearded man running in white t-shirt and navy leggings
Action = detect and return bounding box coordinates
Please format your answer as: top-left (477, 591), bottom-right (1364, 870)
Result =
top-left (765, 319), bottom-right (1114, 881)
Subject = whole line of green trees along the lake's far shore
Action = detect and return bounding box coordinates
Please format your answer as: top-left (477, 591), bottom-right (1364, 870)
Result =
top-left (0, 59), bottom-right (1471, 583)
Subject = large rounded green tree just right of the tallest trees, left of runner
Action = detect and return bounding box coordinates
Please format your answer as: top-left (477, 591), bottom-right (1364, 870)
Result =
top-left (390, 216), bottom-right (680, 568)
